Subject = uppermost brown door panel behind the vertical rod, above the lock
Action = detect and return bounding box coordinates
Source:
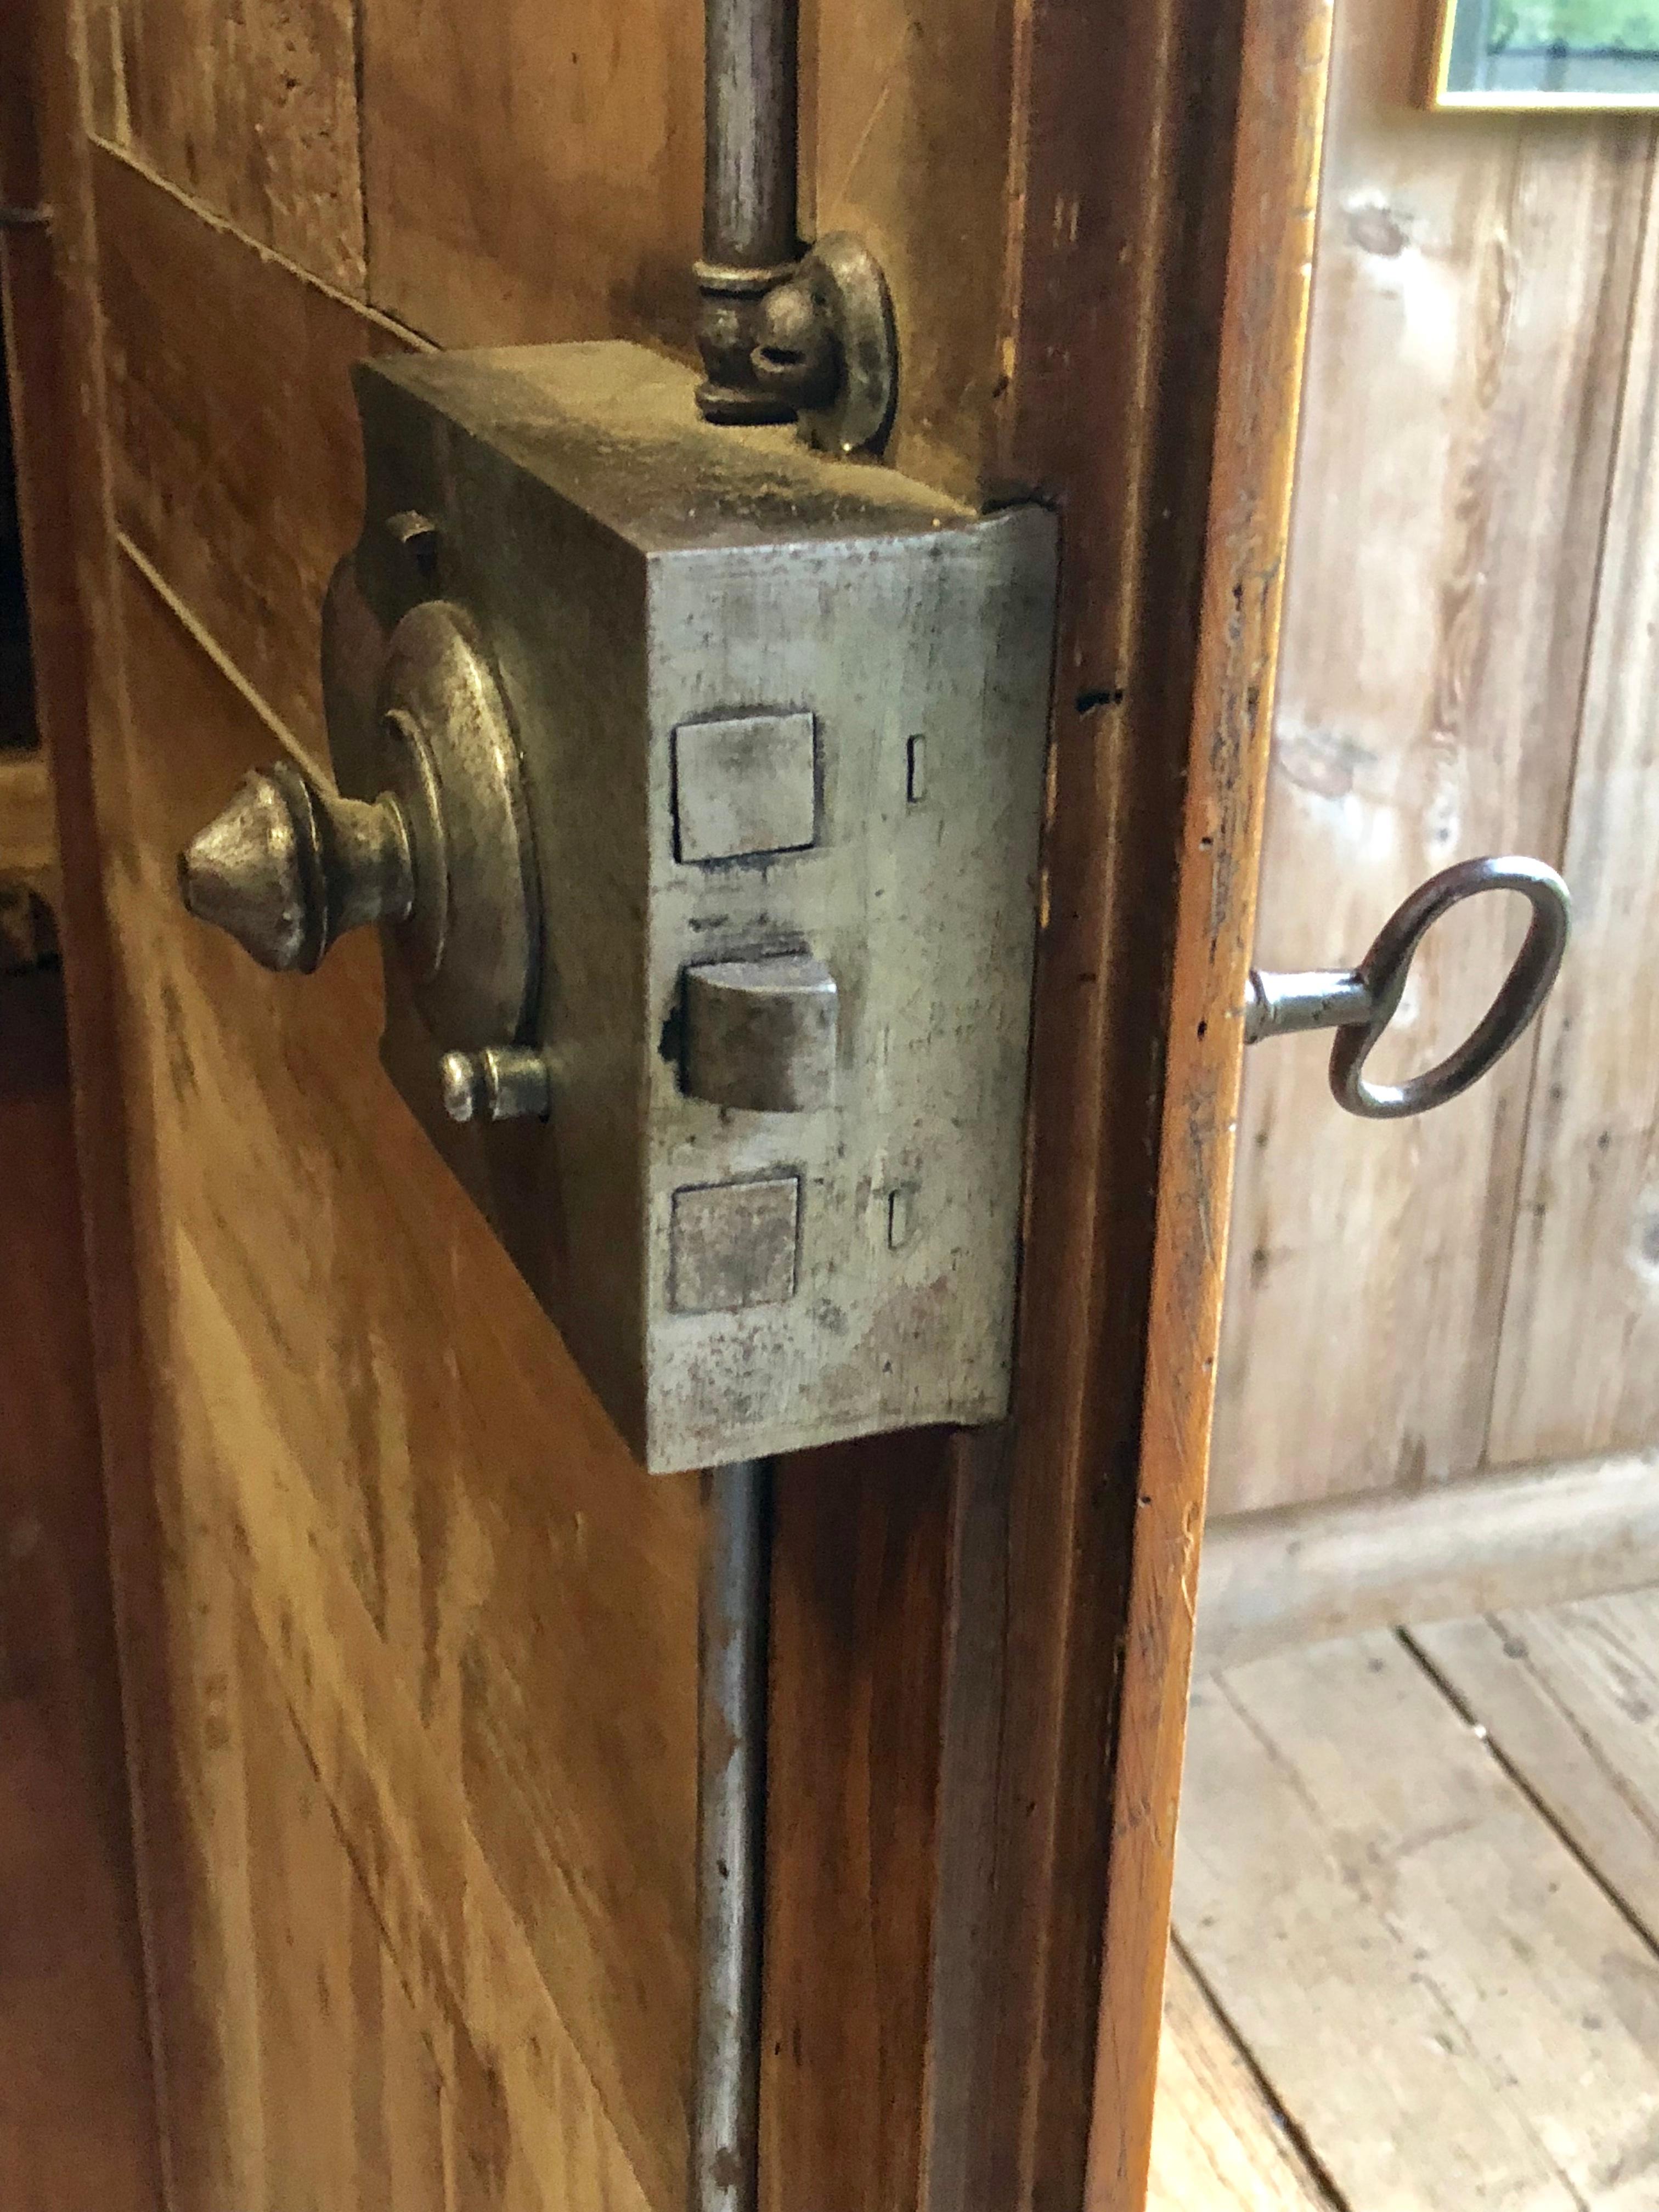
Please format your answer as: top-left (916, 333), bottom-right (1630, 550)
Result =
top-left (358, 0), bottom-right (1015, 498)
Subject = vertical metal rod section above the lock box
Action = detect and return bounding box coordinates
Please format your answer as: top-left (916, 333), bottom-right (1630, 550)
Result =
top-left (703, 0), bottom-right (801, 272)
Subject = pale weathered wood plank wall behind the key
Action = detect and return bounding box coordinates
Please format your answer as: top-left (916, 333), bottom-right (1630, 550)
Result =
top-left (1210, 0), bottom-right (1659, 1513)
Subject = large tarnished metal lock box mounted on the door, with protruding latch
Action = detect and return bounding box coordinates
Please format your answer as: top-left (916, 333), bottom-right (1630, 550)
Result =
top-left (319, 343), bottom-right (1055, 1471)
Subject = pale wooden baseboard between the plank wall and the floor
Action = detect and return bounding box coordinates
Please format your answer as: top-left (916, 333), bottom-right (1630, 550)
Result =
top-left (1194, 1451), bottom-right (1659, 1674)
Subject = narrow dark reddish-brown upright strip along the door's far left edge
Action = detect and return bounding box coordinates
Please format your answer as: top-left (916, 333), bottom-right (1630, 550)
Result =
top-left (0, 0), bottom-right (177, 2203)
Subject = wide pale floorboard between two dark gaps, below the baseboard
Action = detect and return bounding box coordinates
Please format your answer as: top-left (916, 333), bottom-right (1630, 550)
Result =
top-left (1177, 1635), bottom-right (1659, 2212)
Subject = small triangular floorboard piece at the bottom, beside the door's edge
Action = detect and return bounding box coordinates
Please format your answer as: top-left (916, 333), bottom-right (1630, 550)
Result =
top-left (1146, 1951), bottom-right (1334, 2212)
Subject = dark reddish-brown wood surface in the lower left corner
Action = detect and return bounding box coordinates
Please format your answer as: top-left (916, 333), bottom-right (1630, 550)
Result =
top-left (0, 969), bottom-right (161, 2212)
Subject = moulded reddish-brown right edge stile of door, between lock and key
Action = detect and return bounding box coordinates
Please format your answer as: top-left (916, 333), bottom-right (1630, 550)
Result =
top-left (927, 0), bottom-right (1331, 2212)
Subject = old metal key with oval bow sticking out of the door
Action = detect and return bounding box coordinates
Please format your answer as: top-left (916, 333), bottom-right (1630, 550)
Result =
top-left (1245, 856), bottom-right (1573, 1121)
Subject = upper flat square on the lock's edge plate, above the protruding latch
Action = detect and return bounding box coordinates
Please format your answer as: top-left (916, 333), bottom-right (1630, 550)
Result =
top-left (675, 712), bottom-right (819, 860)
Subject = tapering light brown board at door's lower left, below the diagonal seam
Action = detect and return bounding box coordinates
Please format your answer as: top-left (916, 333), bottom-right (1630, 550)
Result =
top-left (138, 1522), bottom-right (465, 2212)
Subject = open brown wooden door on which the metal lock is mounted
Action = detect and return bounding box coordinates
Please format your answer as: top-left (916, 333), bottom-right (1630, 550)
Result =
top-left (0, 0), bottom-right (1327, 2212)
